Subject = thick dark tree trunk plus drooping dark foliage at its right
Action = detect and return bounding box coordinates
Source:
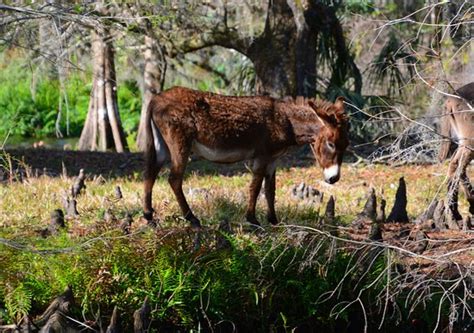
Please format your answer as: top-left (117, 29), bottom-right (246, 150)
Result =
top-left (240, 0), bottom-right (362, 97)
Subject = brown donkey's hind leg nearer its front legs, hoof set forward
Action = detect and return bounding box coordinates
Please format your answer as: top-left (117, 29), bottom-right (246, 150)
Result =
top-left (168, 152), bottom-right (201, 229)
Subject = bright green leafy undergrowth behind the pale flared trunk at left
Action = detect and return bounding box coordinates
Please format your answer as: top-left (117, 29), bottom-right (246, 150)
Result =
top-left (0, 54), bottom-right (141, 138)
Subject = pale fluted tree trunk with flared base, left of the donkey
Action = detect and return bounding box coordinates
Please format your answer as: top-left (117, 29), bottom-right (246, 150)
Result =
top-left (79, 31), bottom-right (128, 152)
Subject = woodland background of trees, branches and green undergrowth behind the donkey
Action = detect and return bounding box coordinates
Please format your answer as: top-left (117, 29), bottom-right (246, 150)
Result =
top-left (0, 0), bottom-right (474, 161)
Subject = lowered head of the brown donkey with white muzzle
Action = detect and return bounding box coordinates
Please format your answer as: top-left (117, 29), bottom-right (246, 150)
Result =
top-left (309, 97), bottom-right (349, 184)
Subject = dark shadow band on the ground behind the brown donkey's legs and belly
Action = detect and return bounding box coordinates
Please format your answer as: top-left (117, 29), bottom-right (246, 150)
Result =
top-left (0, 147), bottom-right (360, 181)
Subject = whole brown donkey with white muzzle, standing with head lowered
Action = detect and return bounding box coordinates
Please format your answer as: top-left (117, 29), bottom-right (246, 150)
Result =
top-left (144, 87), bottom-right (348, 228)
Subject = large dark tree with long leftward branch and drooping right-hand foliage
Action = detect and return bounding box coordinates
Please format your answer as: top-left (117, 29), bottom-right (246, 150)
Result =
top-left (165, 0), bottom-right (362, 96)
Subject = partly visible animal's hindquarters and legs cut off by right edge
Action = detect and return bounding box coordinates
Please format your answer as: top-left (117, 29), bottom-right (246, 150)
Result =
top-left (438, 82), bottom-right (474, 220)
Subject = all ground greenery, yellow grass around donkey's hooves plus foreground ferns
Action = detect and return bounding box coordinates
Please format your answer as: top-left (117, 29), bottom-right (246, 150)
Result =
top-left (0, 158), bottom-right (466, 332)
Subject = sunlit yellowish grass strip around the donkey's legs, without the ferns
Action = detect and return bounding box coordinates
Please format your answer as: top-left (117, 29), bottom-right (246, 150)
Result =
top-left (0, 161), bottom-right (446, 228)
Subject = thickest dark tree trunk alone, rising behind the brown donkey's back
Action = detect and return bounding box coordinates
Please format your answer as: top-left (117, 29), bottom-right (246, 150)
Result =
top-left (247, 0), bottom-right (317, 97)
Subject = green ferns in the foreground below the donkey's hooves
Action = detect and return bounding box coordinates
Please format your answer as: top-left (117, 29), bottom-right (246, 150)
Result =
top-left (0, 226), bottom-right (362, 330)
